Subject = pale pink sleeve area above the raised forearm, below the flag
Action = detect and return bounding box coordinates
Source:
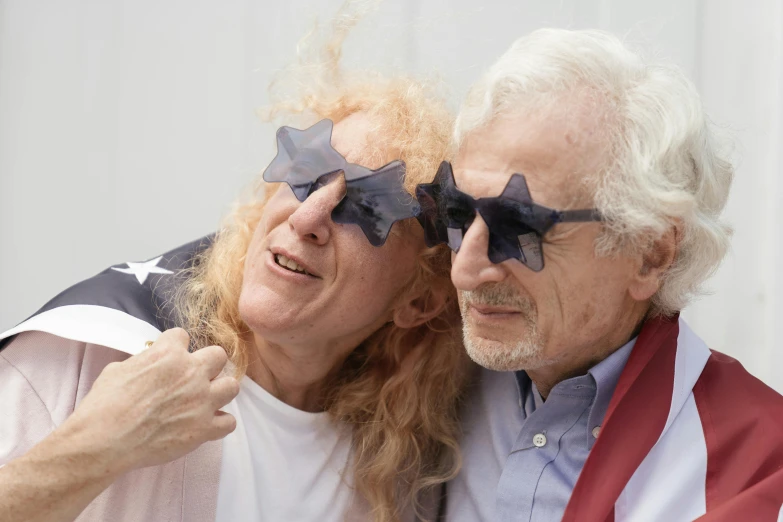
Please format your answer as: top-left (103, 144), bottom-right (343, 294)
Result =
top-left (0, 332), bottom-right (129, 466)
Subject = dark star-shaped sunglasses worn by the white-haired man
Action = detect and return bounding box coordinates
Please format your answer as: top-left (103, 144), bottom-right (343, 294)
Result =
top-left (416, 161), bottom-right (602, 272)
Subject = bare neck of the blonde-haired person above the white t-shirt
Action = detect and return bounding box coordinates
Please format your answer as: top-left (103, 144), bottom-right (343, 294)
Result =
top-left (247, 336), bottom-right (348, 412)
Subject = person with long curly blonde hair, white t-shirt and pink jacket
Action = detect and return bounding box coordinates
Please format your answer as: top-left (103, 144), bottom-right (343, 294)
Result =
top-left (0, 12), bottom-right (472, 522)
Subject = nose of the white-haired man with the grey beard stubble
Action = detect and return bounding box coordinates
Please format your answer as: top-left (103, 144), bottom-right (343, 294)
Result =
top-left (451, 214), bottom-right (506, 291)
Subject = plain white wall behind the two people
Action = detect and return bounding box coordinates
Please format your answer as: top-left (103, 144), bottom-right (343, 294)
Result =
top-left (0, 0), bottom-right (783, 392)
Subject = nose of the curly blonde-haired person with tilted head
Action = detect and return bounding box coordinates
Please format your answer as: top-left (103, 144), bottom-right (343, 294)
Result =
top-left (288, 173), bottom-right (345, 245)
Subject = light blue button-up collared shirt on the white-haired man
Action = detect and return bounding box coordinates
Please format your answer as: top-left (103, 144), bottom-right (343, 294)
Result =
top-left (446, 339), bottom-right (636, 522)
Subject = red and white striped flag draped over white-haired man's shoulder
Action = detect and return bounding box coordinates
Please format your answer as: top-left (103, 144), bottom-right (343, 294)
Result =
top-left (563, 317), bottom-right (783, 522)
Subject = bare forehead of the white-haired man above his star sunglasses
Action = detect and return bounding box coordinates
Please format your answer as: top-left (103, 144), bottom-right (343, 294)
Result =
top-left (454, 102), bottom-right (605, 209)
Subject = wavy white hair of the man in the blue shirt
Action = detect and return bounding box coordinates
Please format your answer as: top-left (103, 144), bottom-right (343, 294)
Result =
top-left (454, 29), bottom-right (734, 315)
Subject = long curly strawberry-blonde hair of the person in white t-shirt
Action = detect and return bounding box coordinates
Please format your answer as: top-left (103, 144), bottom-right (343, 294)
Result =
top-left (178, 5), bottom-right (469, 522)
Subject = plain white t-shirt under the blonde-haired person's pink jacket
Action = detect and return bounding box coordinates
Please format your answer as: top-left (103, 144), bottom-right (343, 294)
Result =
top-left (216, 377), bottom-right (370, 522)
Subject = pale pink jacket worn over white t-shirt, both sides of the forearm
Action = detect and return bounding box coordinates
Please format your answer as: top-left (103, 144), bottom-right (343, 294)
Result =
top-left (0, 332), bottom-right (222, 522)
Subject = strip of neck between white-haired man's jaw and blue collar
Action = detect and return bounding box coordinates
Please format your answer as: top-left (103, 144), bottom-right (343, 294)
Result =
top-left (527, 307), bottom-right (647, 400)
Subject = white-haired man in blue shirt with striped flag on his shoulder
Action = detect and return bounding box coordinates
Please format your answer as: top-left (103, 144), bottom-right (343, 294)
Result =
top-left (432, 30), bottom-right (783, 522)
